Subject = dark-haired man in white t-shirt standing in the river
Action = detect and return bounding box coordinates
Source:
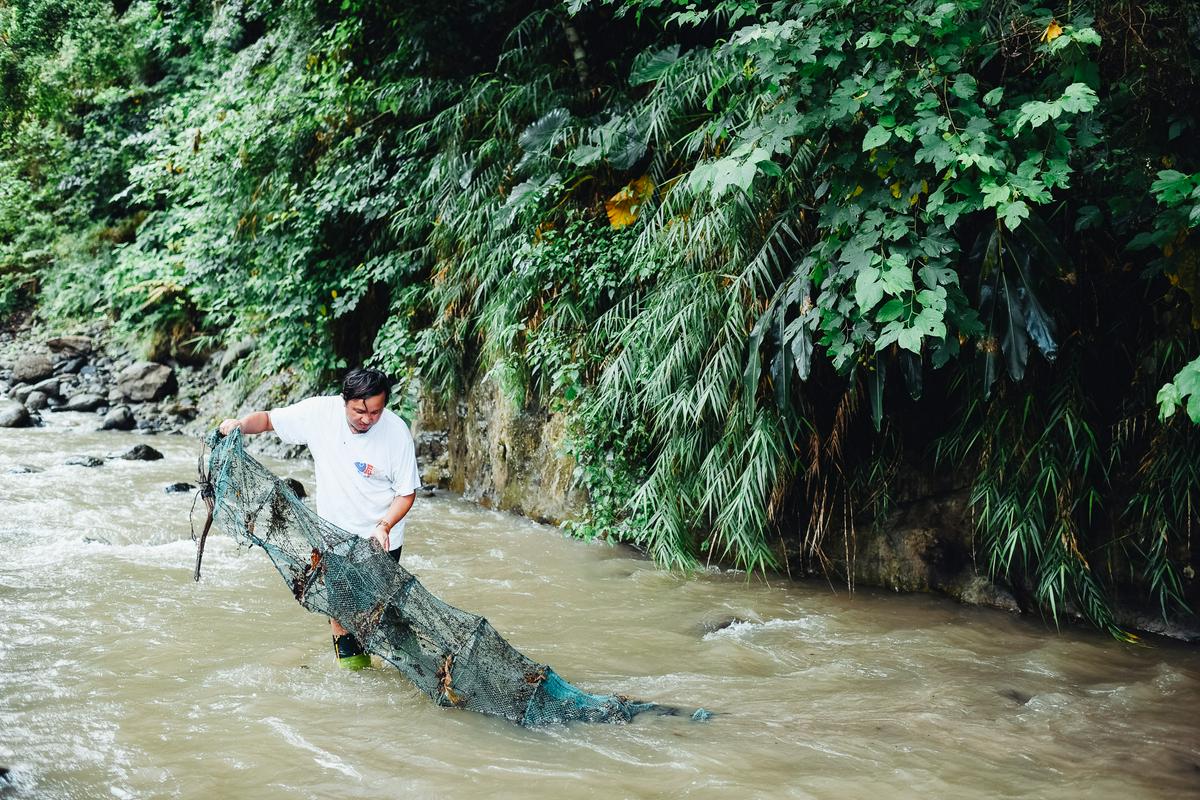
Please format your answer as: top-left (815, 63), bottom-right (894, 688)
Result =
top-left (220, 368), bottom-right (421, 669)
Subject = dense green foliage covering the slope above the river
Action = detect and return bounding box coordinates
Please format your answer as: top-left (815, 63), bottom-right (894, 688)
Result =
top-left (0, 0), bottom-right (1200, 634)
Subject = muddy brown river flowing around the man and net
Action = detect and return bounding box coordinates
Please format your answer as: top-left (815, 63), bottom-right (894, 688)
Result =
top-left (0, 414), bottom-right (1200, 800)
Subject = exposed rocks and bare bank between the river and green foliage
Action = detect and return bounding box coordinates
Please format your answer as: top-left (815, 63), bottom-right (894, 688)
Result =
top-left (0, 321), bottom-right (1200, 642)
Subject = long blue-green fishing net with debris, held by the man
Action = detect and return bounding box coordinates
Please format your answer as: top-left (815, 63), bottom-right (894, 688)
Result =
top-left (196, 431), bottom-right (666, 727)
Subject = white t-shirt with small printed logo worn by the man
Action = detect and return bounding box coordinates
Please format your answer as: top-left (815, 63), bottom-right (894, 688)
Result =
top-left (268, 395), bottom-right (421, 549)
